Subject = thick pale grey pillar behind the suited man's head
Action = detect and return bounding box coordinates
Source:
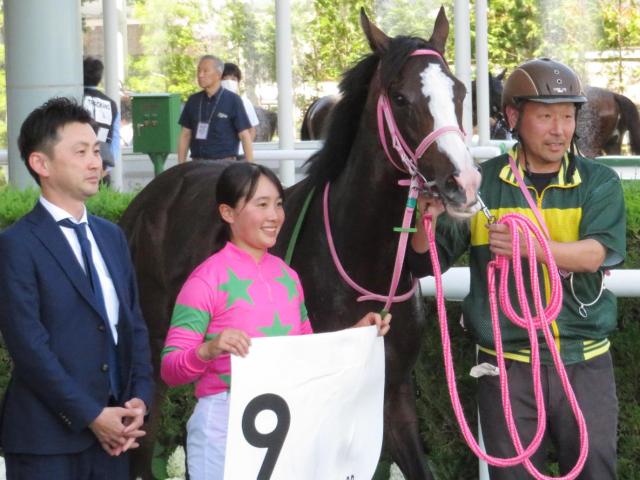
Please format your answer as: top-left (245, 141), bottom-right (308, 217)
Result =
top-left (4, 0), bottom-right (83, 188)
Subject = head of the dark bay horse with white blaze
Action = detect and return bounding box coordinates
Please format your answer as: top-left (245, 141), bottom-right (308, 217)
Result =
top-left (360, 8), bottom-right (480, 218)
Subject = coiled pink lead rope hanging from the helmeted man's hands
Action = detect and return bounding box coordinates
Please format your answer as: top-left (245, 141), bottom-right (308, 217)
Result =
top-left (422, 214), bottom-right (589, 480)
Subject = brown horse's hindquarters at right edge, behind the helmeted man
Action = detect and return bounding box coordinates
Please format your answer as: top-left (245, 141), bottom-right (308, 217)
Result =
top-left (576, 87), bottom-right (640, 157)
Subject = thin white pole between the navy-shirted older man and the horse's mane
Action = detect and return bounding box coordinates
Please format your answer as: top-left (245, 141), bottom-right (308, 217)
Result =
top-left (276, 0), bottom-right (296, 187)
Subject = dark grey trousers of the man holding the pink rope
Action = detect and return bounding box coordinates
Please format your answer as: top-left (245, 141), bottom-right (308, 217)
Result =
top-left (478, 352), bottom-right (618, 480)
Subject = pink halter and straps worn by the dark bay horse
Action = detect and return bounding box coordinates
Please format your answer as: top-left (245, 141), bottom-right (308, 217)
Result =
top-left (323, 49), bottom-right (464, 311)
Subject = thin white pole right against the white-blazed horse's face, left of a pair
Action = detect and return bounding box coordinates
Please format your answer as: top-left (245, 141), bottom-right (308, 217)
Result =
top-left (453, 0), bottom-right (473, 144)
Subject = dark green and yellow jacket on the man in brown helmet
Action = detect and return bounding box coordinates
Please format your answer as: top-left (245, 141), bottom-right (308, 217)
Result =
top-left (424, 150), bottom-right (626, 364)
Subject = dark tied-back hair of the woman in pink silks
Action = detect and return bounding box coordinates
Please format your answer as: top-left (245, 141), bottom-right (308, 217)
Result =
top-left (215, 162), bottom-right (284, 251)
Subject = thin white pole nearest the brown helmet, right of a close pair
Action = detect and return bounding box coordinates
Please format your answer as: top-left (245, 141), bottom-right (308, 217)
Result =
top-left (473, 0), bottom-right (490, 146)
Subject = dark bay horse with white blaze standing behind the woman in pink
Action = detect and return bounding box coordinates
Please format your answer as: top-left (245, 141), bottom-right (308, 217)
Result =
top-left (121, 9), bottom-right (480, 480)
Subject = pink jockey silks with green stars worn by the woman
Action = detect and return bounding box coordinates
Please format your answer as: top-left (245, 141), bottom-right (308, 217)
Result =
top-left (160, 242), bottom-right (313, 398)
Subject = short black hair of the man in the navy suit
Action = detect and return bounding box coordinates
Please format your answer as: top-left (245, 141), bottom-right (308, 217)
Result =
top-left (18, 97), bottom-right (93, 185)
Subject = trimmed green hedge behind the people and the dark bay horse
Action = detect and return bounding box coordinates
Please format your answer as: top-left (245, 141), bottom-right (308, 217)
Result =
top-left (0, 182), bottom-right (640, 480)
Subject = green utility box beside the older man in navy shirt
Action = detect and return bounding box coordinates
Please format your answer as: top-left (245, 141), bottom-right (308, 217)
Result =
top-left (131, 93), bottom-right (180, 175)
